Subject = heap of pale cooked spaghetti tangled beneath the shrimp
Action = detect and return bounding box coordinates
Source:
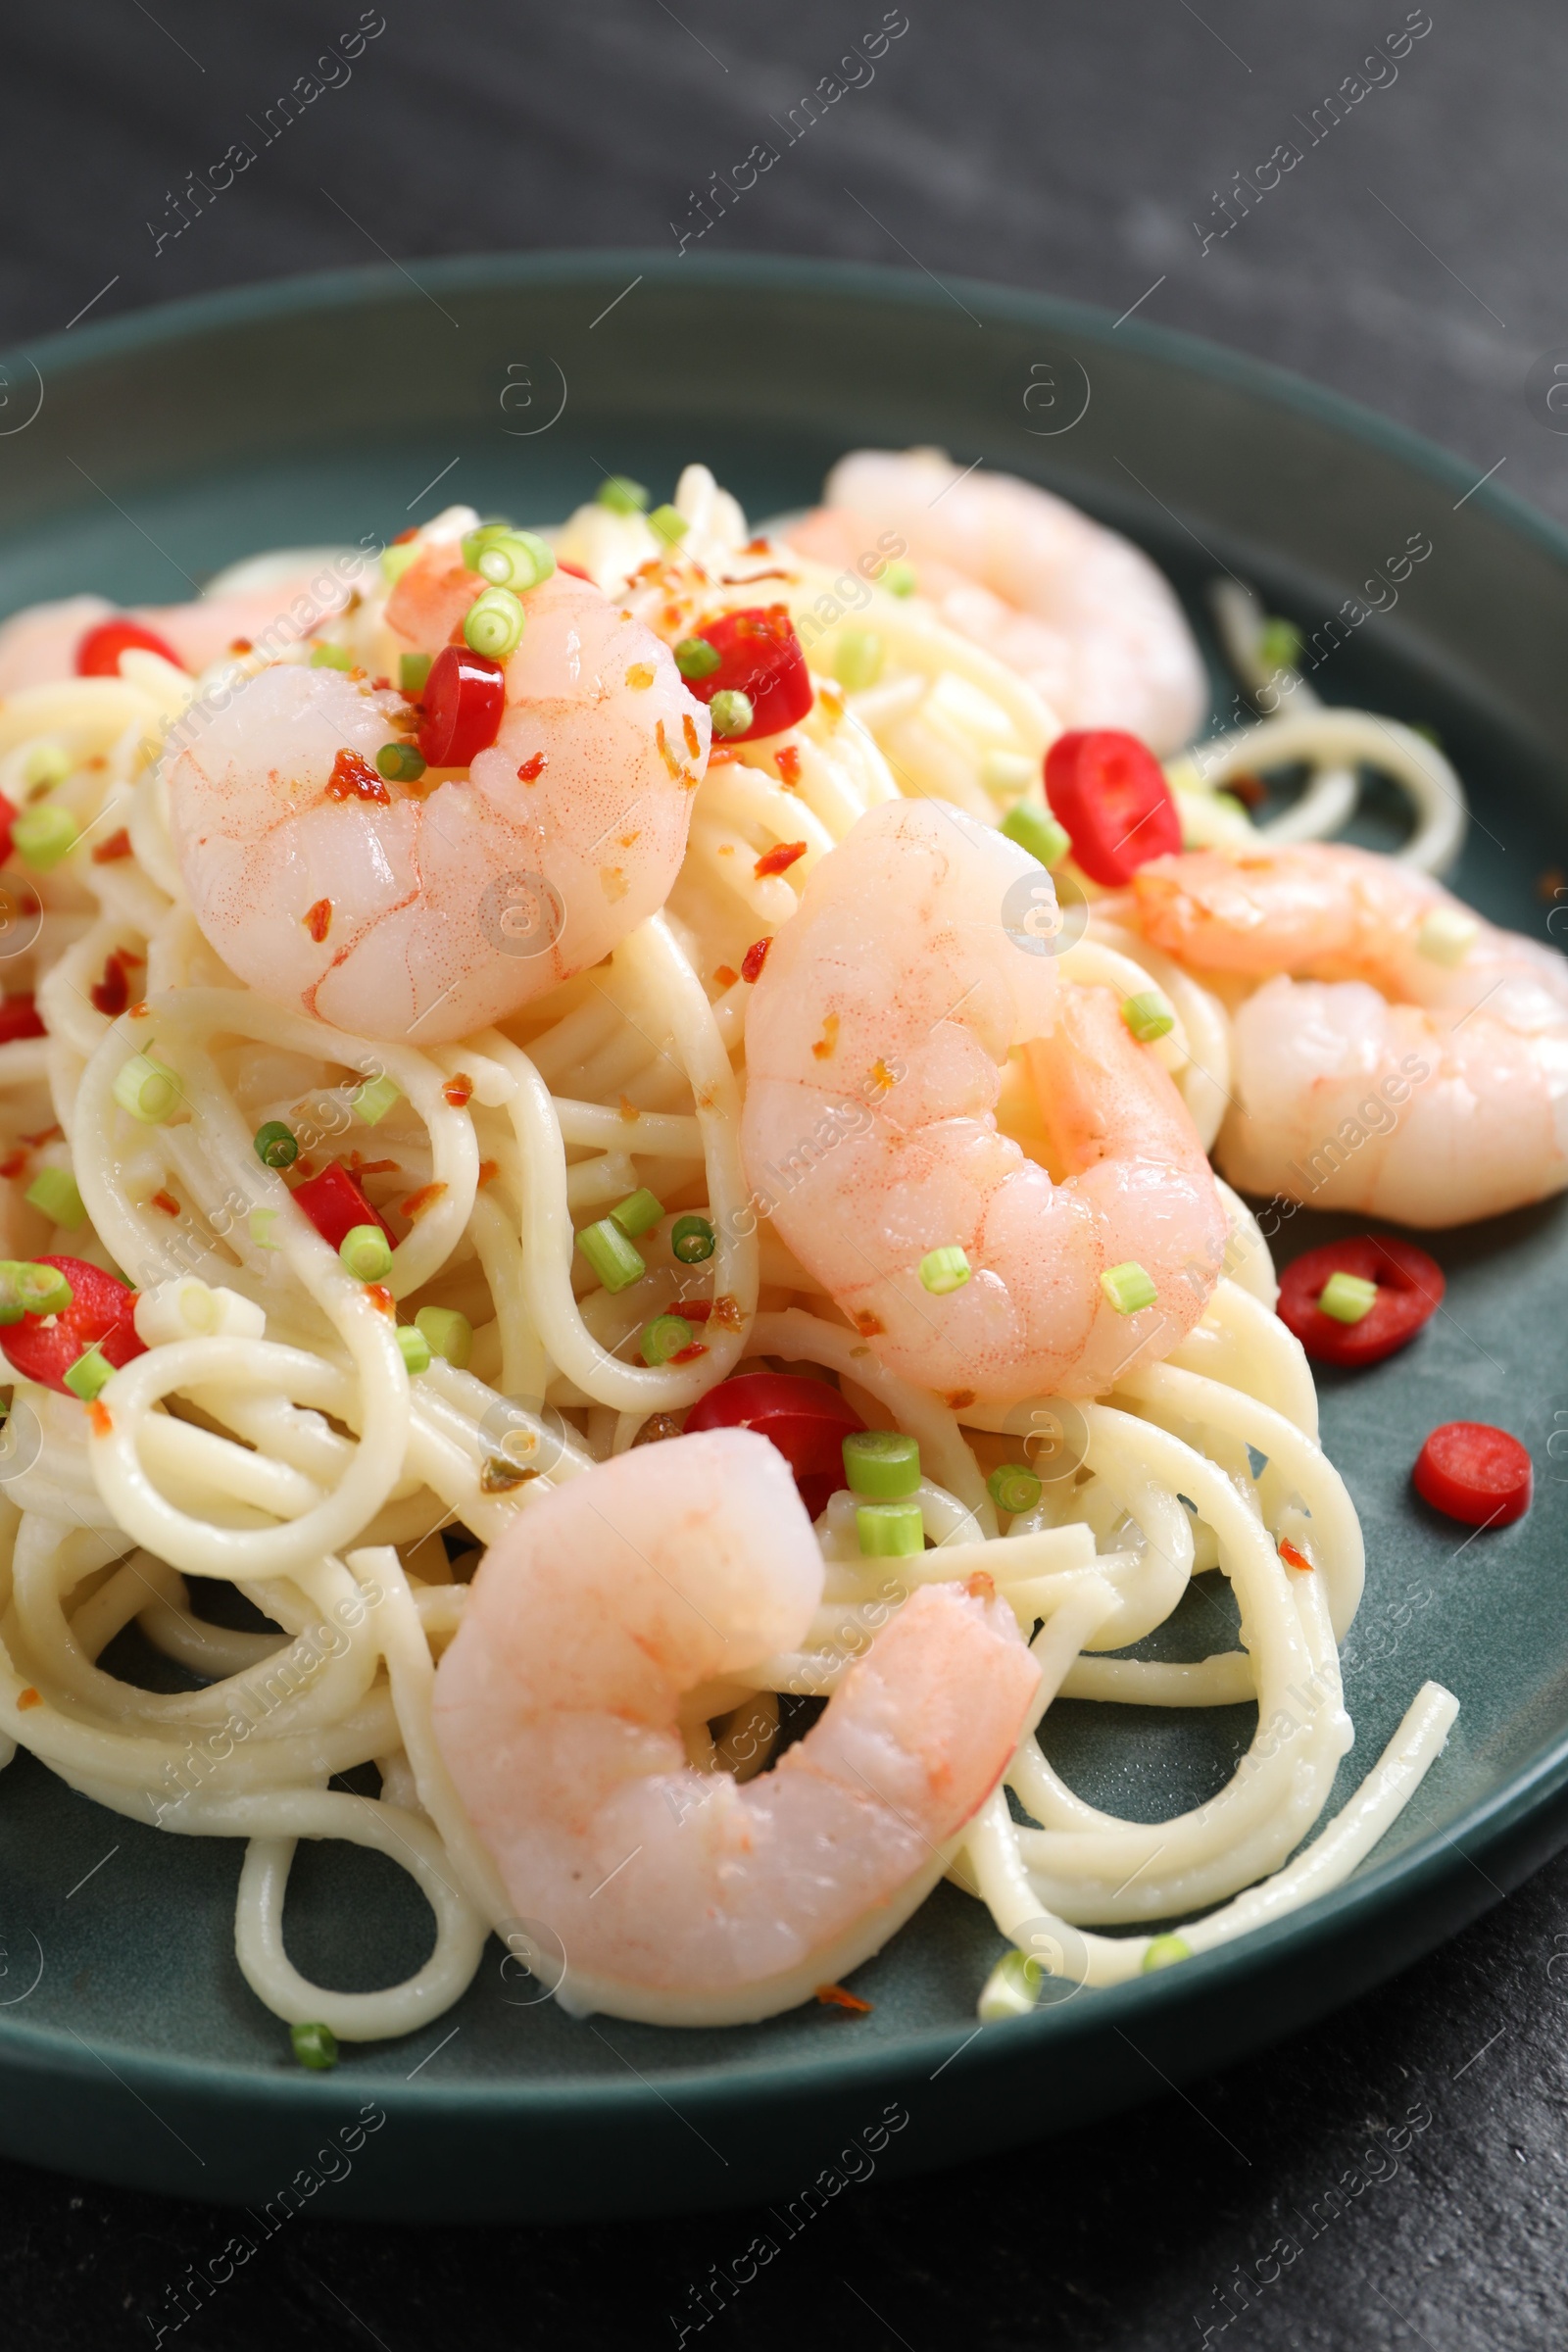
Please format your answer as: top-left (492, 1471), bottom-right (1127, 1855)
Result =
top-left (0, 468), bottom-right (1455, 2039)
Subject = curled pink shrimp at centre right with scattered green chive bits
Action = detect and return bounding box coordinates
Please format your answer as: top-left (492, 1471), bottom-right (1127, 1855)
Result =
top-left (741, 800), bottom-right (1225, 1404)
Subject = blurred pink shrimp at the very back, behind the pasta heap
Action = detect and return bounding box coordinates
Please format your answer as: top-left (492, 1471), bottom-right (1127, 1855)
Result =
top-left (790, 449), bottom-right (1208, 753)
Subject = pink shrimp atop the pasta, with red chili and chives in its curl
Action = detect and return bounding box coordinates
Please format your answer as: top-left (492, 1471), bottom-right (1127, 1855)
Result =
top-left (167, 571), bottom-right (708, 1045)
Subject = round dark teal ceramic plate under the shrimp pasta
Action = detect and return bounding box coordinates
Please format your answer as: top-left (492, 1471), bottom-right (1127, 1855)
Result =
top-left (0, 254), bottom-right (1568, 2218)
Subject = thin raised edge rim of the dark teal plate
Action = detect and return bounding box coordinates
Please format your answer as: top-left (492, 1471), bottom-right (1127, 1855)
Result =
top-left (0, 247), bottom-right (1568, 2144)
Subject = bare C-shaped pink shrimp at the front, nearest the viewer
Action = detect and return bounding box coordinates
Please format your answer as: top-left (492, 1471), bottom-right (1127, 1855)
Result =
top-left (435, 1430), bottom-right (1039, 2025)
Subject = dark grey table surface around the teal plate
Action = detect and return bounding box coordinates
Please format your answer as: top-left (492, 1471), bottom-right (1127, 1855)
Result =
top-left (0, 0), bottom-right (1568, 2352)
